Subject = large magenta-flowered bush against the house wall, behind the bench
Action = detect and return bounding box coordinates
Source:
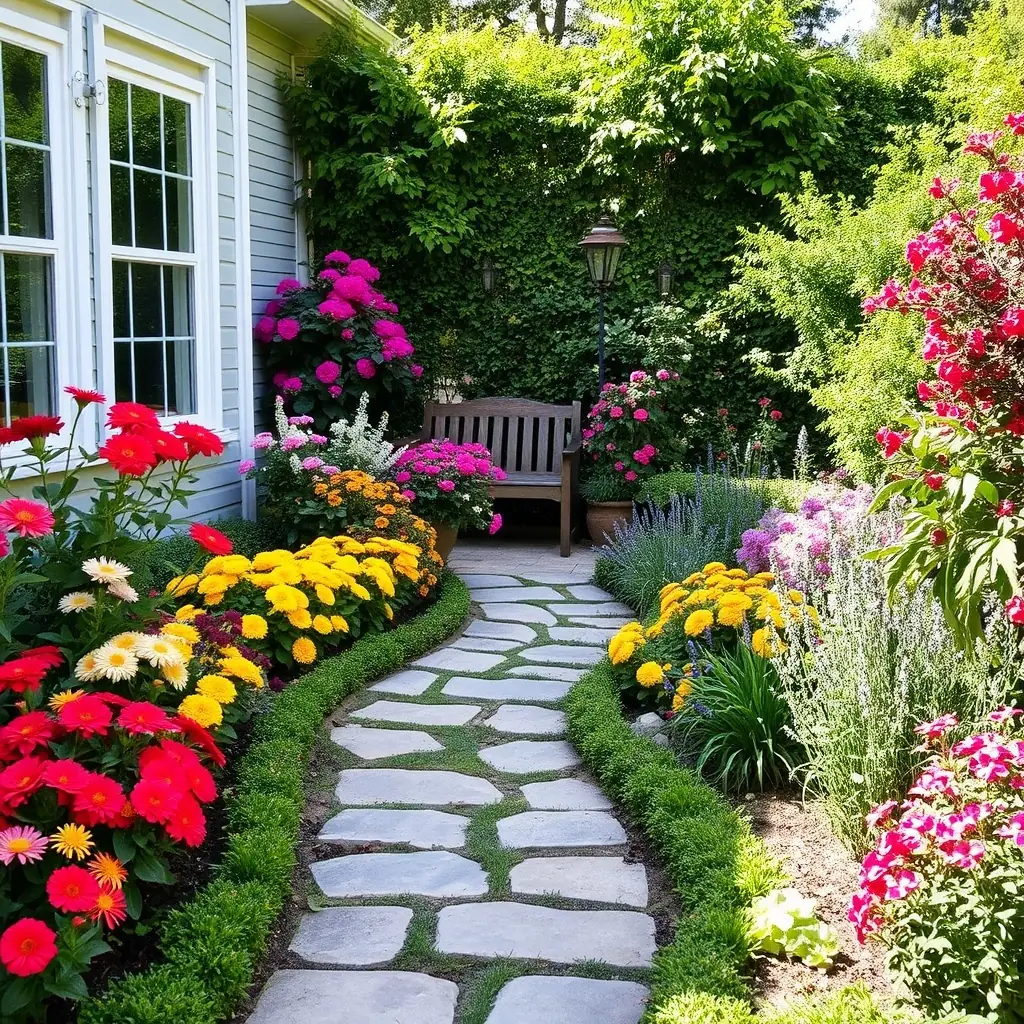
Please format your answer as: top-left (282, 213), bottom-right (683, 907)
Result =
top-left (254, 250), bottom-right (423, 431)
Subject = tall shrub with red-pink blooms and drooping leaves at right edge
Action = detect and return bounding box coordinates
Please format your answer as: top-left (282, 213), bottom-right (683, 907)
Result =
top-left (864, 115), bottom-right (1024, 642)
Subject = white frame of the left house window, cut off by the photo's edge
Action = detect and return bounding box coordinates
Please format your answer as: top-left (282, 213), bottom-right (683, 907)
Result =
top-left (0, 8), bottom-right (81, 452)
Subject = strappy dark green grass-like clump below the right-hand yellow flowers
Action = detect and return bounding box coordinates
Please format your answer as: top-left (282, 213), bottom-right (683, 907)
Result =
top-left (672, 643), bottom-right (803, 793)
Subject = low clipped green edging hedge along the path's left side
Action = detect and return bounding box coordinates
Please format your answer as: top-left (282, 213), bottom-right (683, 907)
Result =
top-left (79, 571), bottom-right (469, 1024)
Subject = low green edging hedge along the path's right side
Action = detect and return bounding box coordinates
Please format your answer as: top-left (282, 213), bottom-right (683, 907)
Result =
top-left (565, 662), bottom-right (902, 1024)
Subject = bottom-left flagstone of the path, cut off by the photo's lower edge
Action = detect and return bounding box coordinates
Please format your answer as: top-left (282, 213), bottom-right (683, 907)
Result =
top-left (249, 971), bottom-right (459, 1024)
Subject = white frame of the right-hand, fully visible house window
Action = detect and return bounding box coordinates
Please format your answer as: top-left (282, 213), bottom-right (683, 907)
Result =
top-left (92, 17), bottom-right (223, 431)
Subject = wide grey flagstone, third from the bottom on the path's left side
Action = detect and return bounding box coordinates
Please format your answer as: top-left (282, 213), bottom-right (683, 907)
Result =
top-left (309, 850), bottom-right (487, 899)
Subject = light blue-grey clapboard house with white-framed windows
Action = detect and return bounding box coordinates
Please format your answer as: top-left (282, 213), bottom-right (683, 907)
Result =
top-left (0, 0), bottom-right (392, 518)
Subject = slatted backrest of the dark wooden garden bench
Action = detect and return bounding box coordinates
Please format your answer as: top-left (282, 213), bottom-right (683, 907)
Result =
top-left (423, 398), bottom-right (581, 474)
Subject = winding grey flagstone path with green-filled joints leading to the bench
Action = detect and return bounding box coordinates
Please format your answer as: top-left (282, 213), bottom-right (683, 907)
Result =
top-left (243, 556), bottom-right (655, 1024)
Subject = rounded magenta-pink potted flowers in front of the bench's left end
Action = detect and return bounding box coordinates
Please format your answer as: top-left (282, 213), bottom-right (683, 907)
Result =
top-left (394, 439), bottom-right (506, 534)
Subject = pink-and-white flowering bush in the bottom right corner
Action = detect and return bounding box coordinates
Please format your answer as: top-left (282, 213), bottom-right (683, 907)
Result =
top-left (849, 707), bottom-right (1024, 1021)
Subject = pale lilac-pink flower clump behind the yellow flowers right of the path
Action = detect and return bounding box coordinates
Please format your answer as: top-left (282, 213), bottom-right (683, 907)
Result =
top-left (736, 483), bottom-right (881, 590)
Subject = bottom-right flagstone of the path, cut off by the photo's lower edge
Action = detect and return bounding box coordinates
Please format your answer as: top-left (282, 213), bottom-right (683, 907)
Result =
top-left (486, 975), bottom-right (648, 1024)
